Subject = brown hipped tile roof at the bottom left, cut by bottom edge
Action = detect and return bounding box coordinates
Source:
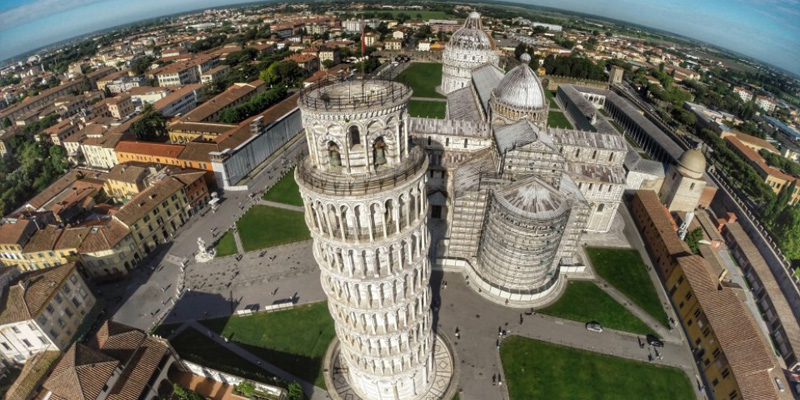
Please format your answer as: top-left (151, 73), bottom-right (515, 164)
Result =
top-left (43, 343), bottom-right (120, 400)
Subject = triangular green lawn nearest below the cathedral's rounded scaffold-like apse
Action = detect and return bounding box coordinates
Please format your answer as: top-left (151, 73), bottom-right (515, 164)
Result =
top-left (539, 281), bottom-right (652, 335)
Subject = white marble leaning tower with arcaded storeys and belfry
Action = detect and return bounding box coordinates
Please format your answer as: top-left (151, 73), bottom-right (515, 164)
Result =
top-left (295, 76), bottom-right (453, 400)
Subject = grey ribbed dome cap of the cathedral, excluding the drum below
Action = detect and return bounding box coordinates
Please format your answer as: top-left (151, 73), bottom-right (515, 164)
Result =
top-left (494, 54), bottom-right (547, 111)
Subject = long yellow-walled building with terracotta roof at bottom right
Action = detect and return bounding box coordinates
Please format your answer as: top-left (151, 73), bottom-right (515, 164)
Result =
top-left (665, 255), bottom-right (793, 400)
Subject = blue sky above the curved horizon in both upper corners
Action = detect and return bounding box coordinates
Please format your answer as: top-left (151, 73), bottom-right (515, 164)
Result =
top-left (0, 0), bottom-right (800, 76)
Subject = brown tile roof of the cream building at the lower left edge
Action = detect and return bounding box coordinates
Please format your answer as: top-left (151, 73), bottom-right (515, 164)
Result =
top-left (0, 263), bottom-right (75, 325)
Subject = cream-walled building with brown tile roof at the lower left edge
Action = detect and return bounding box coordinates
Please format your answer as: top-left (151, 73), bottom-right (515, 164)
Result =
top-left (0, 263), bottom-right (95, 364)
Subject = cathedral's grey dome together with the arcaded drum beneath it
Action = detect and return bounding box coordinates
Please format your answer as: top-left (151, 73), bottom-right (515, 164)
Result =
top-left (490, 54), bottom-right (548, 123)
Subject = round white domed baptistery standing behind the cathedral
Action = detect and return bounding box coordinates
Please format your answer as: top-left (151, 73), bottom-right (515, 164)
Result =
top-left (441, 12), bottom-right (500, 94)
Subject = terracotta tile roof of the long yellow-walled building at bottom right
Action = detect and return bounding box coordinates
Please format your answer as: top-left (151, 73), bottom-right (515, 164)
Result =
top-left (677, 255), bottom-right (783, 400)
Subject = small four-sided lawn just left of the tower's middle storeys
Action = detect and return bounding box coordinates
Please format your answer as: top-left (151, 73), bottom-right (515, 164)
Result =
top-left (236, 205), bottom-right (311, 251)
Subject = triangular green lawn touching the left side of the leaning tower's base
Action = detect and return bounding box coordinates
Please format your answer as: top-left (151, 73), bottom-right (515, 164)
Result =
top-left (201, 303), bottom-right (336, 387)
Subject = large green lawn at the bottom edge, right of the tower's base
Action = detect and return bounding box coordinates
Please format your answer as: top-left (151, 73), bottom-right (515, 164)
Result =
top-left (500, 336), bottom-right (695, 400)
